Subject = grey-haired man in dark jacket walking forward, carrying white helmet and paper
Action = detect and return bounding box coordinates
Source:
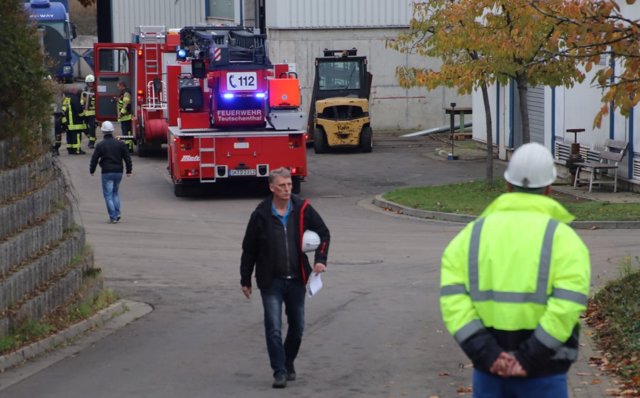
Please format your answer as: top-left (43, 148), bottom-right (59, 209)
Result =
top-left (240, 168), bottom-right (330, 388)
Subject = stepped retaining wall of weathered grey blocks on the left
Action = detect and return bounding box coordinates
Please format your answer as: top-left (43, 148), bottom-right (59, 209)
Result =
top-left (0, 145), bottom-right (102, 336)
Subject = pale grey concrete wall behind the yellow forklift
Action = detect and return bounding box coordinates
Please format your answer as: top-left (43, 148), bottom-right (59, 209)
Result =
top-left (268, 29), bottom-right (471, 131)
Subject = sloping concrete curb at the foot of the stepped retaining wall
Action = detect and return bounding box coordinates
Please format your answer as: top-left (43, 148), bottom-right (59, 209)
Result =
top-left (0, 300), bottom-right (153, 374)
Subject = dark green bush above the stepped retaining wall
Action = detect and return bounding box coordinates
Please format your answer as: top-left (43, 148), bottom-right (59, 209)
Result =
top-left (0, 0), bottom-right (53, 165)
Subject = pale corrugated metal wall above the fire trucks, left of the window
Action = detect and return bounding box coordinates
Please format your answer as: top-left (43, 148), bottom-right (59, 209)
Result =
top-left (111, 0), bottom-right (206, 43)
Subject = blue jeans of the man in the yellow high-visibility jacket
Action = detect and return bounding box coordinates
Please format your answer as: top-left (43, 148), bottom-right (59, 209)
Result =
top-left (473, 370), bottom-right (569, 398)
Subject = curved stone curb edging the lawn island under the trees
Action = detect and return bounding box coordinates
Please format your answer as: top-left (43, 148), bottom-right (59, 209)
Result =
top-left (371, 195), bottom-right (640, 229)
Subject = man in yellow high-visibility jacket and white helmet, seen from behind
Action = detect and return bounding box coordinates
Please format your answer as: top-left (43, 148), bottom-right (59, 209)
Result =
top-left (440, 143), bottom-right (591, 398)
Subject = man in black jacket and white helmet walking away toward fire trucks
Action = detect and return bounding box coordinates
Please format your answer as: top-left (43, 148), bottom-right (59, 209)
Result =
top-left (89, 121), bottom-right (132, 224)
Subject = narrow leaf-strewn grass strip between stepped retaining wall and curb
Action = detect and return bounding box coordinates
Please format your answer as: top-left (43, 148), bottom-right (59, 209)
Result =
top-left (0, 289), bottom-right (118, 355)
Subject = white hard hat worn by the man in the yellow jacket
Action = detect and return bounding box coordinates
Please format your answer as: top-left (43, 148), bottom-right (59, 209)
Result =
top-left (504, 142), bottom-right (557, 188)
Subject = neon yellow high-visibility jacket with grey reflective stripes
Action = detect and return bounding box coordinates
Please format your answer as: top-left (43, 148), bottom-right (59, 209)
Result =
top-left (440, 193), bottom-right (590, 375)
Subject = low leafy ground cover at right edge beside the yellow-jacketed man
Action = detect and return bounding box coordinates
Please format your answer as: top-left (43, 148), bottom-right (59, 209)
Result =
top-left (585, 257), bottom-right (640, 397)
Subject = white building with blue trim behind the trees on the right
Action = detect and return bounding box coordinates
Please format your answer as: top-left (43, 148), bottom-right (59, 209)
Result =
top-left (472, 2), bottom-right (640, 184)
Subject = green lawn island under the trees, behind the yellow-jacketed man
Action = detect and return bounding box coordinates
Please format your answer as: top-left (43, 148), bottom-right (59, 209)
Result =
top-left (384, 181), bottom-right (640, 221)
